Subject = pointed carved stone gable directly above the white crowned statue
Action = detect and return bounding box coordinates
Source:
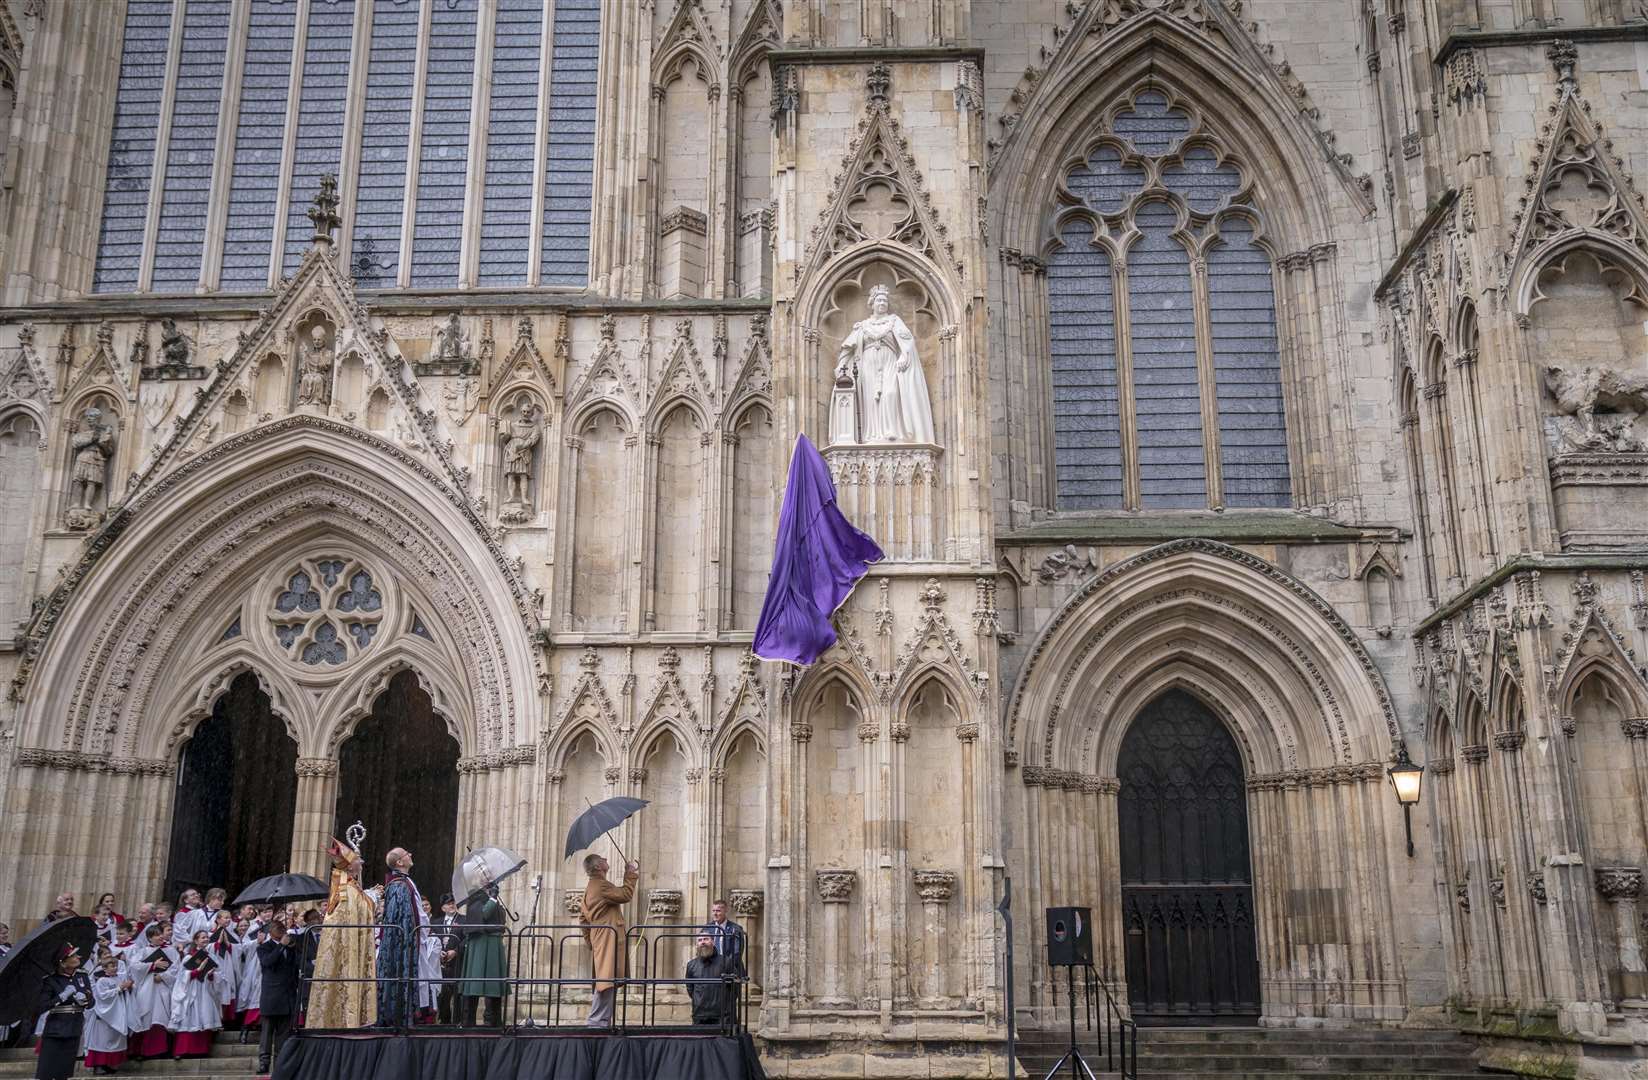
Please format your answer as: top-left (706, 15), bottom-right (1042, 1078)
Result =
top-left (798, 64), bottom-right (962, 277)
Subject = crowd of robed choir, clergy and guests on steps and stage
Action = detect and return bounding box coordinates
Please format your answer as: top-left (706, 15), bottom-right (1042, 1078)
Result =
top-left (0, 841), bottom-right (745, 1080)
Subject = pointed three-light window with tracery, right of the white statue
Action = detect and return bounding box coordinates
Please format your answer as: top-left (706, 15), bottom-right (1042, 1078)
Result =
top-left (1046, 89), bottom-right (1292, 509)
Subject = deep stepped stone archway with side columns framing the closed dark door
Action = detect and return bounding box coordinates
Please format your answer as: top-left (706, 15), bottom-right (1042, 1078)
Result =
top-left (1007, 541), bottom-right (1404, 1024)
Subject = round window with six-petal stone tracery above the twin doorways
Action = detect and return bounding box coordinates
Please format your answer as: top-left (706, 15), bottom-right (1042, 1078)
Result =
top-left (269, 557), bottom-right (384, 668)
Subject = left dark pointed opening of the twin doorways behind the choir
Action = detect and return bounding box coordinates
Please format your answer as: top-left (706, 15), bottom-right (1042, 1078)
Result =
top-left (166, 671), bottom-right (298, 899)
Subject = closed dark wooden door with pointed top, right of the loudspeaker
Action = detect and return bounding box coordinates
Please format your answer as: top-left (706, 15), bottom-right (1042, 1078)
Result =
top-left (1117, 691), bottom-right (1259, 1024)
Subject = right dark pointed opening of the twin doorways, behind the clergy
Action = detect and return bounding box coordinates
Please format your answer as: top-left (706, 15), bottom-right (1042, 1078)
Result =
top-left (335, 671), bottom-right (458, 905)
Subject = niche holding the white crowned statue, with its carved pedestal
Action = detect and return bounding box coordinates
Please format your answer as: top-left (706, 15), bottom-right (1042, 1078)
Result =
top-left (817, 264), bottom-right (954, 561)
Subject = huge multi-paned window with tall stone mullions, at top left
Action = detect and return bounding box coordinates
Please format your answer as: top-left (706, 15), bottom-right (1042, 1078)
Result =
top-left (92, 0), bottom-right (602, 293)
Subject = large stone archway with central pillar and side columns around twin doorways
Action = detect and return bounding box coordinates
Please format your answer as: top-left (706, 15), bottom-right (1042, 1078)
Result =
top-left (0, 416), bottom-right (539, 910)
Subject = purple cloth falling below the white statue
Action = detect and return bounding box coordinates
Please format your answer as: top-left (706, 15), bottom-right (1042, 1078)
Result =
top-left (751, 435), bottom-right (885, 664)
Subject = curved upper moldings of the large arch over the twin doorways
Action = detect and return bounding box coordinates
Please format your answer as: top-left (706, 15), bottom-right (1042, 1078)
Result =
top-left (20, 417), bottom-right (537, 754)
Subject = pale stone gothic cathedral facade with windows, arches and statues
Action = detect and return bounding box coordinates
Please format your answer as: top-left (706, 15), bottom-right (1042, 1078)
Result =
top-left (0, 0), bottom-right (1648, 1077)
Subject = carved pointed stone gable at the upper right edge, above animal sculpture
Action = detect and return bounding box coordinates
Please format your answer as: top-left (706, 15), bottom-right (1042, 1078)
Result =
top-left (1501, 41), bottom-right (1648, 285)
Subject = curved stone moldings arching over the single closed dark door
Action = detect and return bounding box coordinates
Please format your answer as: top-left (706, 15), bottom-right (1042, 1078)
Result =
top-left (1007, 539), bottom-right (1401, 768)
